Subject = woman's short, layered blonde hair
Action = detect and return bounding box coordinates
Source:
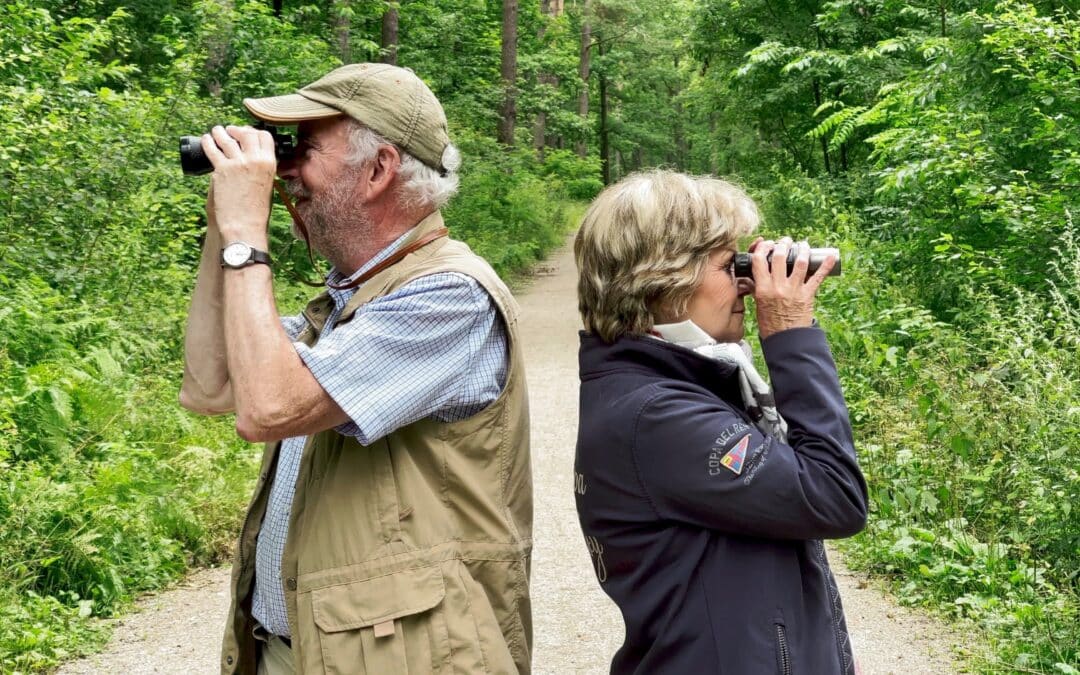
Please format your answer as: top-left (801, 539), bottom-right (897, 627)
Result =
top-left (573, 170), bottom-right (759, 342)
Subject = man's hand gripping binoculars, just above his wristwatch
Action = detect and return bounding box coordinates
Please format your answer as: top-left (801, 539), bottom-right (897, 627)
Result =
top-left (202, 126), bottom-right (278, 249)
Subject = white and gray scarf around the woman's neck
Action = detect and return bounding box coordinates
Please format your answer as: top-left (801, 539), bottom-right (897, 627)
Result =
top-left (652, 320), bottom-right (787, 443)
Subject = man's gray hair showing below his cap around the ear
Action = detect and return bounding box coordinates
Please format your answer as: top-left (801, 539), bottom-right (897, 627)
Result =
top-left (346, 119), bottom-right (461, 208)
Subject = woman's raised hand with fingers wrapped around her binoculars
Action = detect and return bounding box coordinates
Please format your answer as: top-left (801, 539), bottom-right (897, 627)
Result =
top-left (750, 237), bottom-right (836, 339)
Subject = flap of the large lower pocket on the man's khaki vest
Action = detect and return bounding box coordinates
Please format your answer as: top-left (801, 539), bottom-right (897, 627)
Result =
top-left (311, 566), bottom-right (446, 633)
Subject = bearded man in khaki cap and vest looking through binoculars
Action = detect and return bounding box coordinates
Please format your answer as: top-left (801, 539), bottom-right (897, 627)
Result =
top-left (180, 64), bottom-right (532, 675)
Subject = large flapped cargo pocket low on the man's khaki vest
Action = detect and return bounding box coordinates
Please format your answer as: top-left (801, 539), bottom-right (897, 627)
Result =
top-left (311, 566), bottom-right (450, 675)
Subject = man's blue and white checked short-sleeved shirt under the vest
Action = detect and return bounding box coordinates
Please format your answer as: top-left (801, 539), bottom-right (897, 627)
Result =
top-left (252, 232), bottom-right (508, 637)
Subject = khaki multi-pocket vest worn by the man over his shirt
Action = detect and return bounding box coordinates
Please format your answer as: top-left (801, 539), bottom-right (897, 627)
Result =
top-left (221, 213), bottom-right (532, 675)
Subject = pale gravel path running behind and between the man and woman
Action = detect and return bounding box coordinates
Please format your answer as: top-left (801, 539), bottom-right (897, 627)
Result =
top-left (59, 236), bottom-right (963, 675)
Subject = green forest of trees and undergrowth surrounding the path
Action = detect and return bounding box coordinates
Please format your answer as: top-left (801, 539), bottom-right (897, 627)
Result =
top-left (0, 0), bottom-right (1080, 674)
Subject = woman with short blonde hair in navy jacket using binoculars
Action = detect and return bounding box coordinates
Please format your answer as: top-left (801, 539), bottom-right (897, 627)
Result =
top-left (575, 171), bottom-right (866, 675)
